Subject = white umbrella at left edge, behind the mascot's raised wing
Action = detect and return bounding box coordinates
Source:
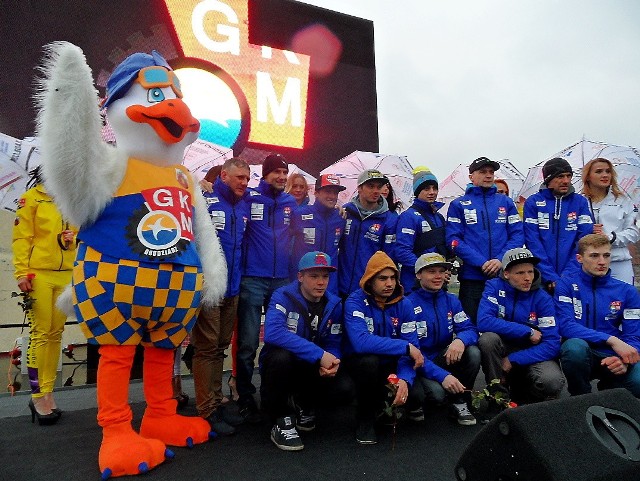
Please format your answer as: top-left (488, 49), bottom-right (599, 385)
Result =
top-left (0, 133), bottom-right (42, 212)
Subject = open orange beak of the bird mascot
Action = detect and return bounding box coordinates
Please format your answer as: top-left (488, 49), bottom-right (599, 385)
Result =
top-left (126, 98), bottom-right (200, 144)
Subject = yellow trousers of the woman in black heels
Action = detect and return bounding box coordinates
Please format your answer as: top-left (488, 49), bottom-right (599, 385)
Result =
top-left (27, 269), bottom-right (72, 398)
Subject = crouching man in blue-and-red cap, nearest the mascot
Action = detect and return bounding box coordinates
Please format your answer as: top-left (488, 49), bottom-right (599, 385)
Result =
top-left (260, 251), bottom-right (353, 451)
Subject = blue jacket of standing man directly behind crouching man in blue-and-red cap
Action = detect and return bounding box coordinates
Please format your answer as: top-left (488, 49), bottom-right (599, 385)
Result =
top-left (290, 201), bottom-right (346, 294)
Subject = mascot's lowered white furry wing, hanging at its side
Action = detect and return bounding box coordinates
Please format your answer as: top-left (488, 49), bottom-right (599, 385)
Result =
top-left (194, 189), bottom-right (227, 307)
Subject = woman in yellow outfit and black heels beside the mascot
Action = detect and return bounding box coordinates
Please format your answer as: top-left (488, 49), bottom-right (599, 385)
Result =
top-left (13, 168), bottom-right (77, 425)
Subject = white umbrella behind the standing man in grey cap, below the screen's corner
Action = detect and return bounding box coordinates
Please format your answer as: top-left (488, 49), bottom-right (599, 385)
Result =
top-left (320, 150), bottom-right (413, 209)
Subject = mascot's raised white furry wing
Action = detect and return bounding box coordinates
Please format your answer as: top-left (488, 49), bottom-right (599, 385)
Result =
top-left (35, 42), bottom-right (126, 226)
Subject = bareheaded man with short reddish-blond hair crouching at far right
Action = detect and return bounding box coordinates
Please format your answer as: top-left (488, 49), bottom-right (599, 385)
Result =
top-left (554, 234), bottom-right (640, 397)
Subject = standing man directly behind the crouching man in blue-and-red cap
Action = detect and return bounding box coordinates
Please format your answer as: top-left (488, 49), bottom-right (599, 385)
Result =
top-left (290, 174), bottom-right (346, 295)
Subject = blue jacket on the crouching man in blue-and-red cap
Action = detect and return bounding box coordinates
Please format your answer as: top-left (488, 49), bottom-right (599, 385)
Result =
top-left (260, 281), bottom-right (342, 363)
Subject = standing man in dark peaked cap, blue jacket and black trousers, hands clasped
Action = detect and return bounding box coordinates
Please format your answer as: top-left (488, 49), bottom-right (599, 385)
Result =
top-left (446, 157), bottom-right (524, 324)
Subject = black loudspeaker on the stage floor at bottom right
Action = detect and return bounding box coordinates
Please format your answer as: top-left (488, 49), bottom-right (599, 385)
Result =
top-left (455, 389), bottom-right (640, 481)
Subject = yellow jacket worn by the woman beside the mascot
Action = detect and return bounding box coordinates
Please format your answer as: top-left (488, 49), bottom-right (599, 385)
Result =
top-left (12, 184), bottom-right (78, 279)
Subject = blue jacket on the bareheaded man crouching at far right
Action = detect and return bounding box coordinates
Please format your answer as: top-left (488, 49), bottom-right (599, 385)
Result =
top-left (554, 269), bottom-right (640, 355)
